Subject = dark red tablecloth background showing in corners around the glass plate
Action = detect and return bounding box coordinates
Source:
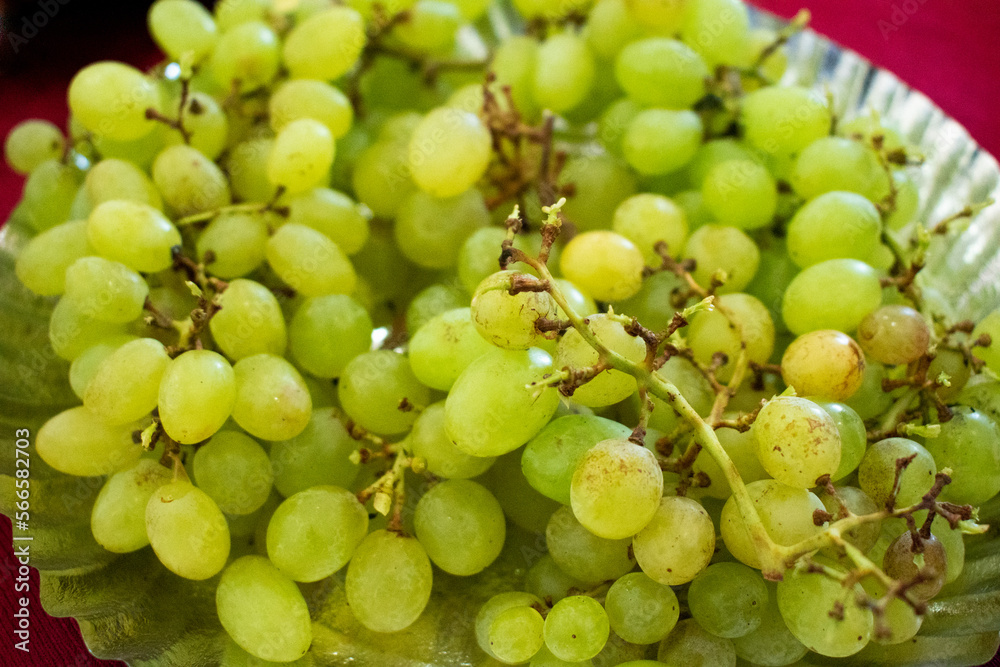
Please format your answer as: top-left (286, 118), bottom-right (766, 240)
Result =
top-left (0, 0), bottom-right (1000, 667)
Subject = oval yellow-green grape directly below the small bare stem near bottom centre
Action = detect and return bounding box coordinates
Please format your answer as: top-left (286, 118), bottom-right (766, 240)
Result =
top-left (345, 530), bottom-right (433, 632)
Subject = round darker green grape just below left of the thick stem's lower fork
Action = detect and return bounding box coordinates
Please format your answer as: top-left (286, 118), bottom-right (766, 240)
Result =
top-left (688, 563), bottom-right (770, 639)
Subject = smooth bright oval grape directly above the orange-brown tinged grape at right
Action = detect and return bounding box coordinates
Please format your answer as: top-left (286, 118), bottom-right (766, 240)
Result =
top-left (780, 258), bottom-right (882, 335)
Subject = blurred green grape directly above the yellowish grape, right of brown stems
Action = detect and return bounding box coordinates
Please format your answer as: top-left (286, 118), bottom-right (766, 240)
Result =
top-left (559, 154), bottom-right (636, 232)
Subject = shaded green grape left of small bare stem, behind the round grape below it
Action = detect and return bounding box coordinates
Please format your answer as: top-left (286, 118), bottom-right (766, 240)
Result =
top-left (271, 407), bottom-right (360, 498)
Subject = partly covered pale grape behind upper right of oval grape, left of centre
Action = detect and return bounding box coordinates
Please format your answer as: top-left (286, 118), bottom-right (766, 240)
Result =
top-left (288, 188), bottom-right (368, 255)
